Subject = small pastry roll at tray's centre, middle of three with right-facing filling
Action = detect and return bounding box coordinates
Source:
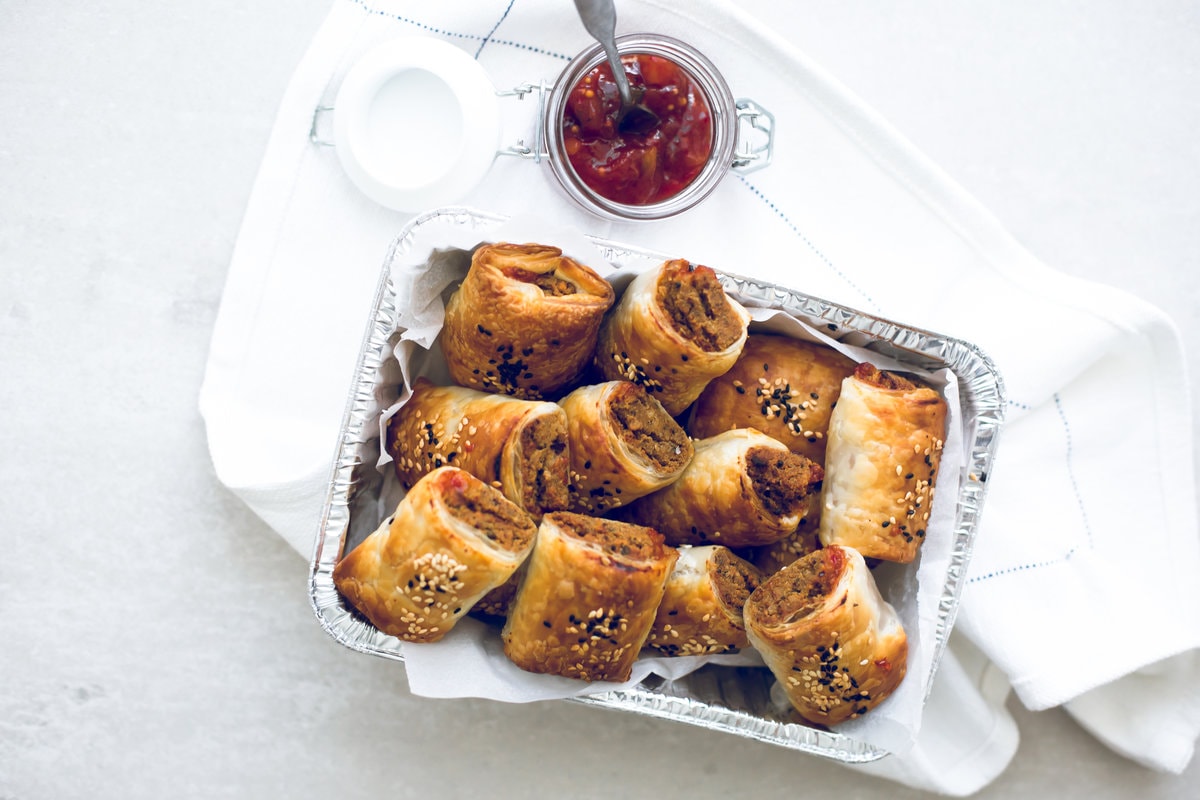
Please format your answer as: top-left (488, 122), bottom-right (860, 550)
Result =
top-left (558, 380), bottom-right (694, 515)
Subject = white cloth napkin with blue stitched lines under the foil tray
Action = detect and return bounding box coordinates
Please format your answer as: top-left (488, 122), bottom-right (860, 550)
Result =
top-left (199, 0), bottom-right (1200, 795)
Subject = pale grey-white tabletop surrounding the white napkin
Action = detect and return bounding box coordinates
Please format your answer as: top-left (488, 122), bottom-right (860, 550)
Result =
top-left (0, 0), bottom-right (1200, 800)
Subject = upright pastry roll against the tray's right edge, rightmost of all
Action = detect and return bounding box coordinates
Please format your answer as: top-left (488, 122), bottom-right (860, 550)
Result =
top-left (820, 363), bottom-right (947, 563)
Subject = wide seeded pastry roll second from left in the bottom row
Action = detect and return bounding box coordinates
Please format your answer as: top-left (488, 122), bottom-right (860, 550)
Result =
top-left (500, 511), bottom-right (678, 681)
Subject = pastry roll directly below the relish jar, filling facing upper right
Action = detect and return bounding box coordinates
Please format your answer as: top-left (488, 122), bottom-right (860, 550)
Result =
top-left (596, 259), bottom-right (750, 416)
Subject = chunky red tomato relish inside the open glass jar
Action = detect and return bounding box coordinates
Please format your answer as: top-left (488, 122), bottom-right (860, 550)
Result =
top-left (563, 53), bottom-right (713, 205)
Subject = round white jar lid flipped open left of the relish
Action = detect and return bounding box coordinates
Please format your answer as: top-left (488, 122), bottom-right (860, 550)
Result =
top-left (334, 37), bottom-right (500, 211)
